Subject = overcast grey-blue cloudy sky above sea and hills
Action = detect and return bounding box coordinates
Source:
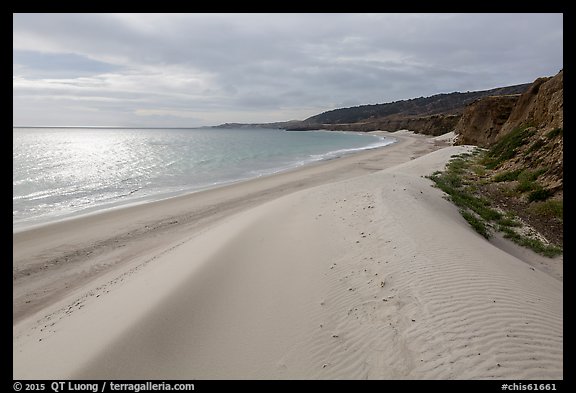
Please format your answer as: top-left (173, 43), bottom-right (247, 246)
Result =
top-left (13, 14), bottom-right (563, 127)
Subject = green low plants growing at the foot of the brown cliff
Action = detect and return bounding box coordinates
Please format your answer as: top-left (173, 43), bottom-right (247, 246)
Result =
top-left (428, 148), bottom-right (563, 257)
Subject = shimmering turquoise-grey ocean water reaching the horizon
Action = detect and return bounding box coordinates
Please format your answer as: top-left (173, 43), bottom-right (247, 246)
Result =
top-left (13, 128), bottom-right (395, 229)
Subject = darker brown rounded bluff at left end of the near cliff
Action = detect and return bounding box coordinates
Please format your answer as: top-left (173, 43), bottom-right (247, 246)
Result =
top-left (454, 94), bottom-right (520, 147)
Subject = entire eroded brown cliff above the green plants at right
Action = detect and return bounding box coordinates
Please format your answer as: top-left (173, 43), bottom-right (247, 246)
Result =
top-left (455, 71), bottom-right (564, 194)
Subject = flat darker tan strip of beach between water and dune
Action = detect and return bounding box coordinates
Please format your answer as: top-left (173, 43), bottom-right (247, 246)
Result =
top-left (13, 131), bottom-right (440, 323)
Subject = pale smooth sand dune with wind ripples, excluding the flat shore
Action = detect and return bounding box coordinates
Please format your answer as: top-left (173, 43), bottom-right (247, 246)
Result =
top-left (13, 146), bottom-right (563, 379)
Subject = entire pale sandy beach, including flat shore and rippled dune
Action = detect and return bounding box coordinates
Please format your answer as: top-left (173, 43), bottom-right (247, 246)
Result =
top-left (13, 131), bottom-right (563, 379)
